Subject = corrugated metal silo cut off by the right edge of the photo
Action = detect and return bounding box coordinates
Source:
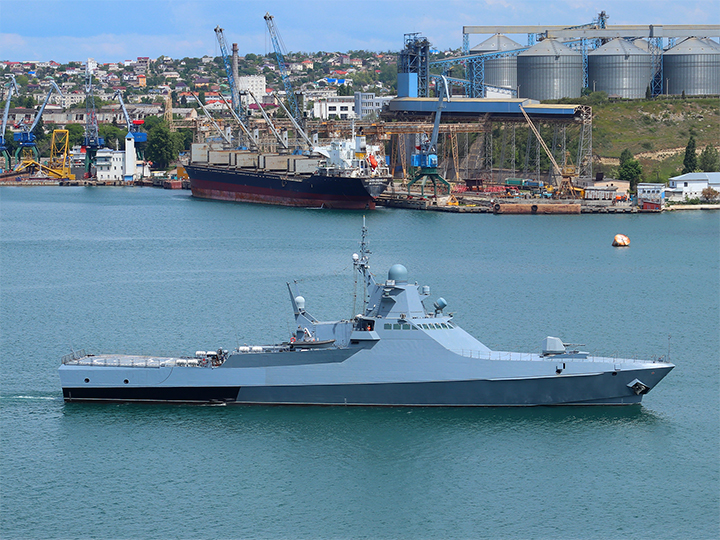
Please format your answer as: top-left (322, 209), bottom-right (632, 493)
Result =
top-left (663, 38), bottom-right (720, 96)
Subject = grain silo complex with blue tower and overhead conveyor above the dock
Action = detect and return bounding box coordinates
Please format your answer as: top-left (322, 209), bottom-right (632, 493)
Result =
top-left (398, 12), bottom-right (720, 101)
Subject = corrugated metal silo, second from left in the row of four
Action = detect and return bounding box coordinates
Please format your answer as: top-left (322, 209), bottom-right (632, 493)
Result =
top-left (517, 39), bottom-right (583, 101)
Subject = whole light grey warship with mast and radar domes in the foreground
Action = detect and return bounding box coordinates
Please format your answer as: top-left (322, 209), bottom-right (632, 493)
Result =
top-left (59, 221), bottom-right (675, 407)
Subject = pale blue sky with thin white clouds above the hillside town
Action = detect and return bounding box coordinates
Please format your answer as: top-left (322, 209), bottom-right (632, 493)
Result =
top-left (0, 0), bottom-right (720, 63)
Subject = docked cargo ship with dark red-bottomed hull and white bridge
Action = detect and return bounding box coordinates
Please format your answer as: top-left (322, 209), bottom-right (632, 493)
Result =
top-left (185, 136), bottom-right (391, 210)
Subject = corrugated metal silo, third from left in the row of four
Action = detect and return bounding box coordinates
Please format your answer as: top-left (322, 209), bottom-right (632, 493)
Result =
top-left (588, 39), bottom-right (652, 99)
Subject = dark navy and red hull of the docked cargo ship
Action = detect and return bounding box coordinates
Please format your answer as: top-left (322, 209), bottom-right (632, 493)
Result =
top-left (185, 165), bottom-right (390, 210)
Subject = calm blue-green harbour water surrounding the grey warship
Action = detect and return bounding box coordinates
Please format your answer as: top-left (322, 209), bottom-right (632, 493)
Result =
top-left (0, 187), bottom-right (720, 539)
